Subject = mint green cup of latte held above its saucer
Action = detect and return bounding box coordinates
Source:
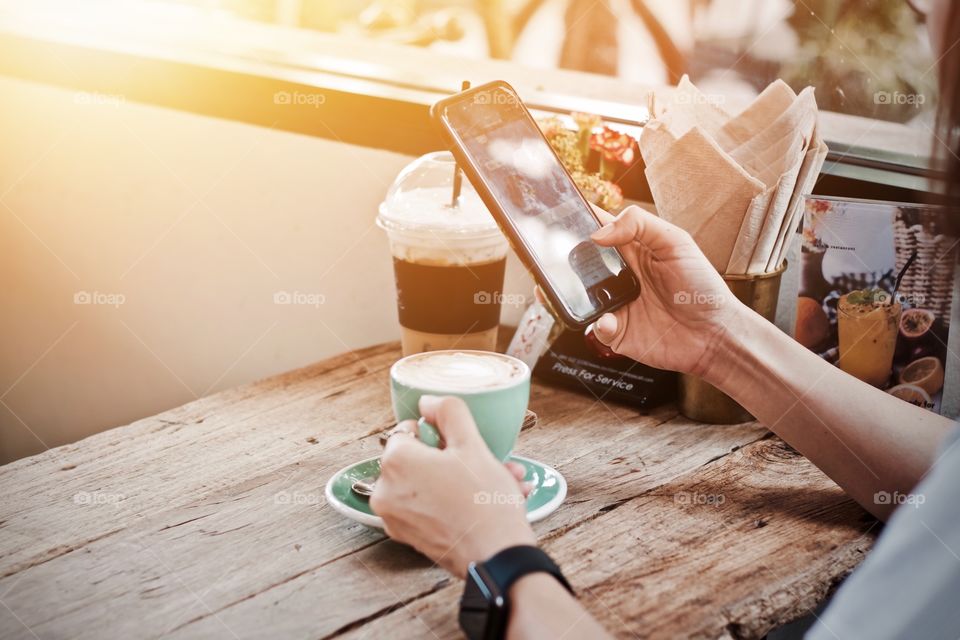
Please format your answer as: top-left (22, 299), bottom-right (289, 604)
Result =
top-left (390, 351), bottom-right (530, 461)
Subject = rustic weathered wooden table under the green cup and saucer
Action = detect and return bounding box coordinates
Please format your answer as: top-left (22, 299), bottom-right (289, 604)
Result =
top-left (0, 344), bottom-right (874, 638)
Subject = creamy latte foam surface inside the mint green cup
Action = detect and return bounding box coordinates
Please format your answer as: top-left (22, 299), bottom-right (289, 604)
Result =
top-left (393, 351), bottom-right (528, 393)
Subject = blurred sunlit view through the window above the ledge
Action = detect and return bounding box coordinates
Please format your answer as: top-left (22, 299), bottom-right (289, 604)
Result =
top-left (18, 0), bottom-right (937, 167)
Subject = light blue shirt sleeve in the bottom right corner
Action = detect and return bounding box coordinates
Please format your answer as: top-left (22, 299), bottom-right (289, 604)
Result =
top-left (806, 429), bottom-right (960, 640)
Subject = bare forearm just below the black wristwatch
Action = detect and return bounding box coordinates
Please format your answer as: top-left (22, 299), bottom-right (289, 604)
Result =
top-left (507, 573), bottom-right (610, 640)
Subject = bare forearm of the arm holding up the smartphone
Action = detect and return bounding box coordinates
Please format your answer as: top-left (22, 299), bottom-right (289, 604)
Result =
top-left (705, 307), bottom-right (953, 518)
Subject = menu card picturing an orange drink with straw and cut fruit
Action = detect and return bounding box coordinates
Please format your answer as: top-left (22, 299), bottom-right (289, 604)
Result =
top-left (795, 196), bottom-right (960, 412)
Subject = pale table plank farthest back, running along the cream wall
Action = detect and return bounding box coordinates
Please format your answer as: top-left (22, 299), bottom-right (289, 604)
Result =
top-left (0, 347), bottom-right (396, 576)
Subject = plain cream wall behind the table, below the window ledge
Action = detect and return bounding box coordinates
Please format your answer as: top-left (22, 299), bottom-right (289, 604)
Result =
top-left (0, 78), bottom-right (531, 461)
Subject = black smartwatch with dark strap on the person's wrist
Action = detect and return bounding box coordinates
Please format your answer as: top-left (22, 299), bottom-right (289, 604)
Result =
top-left (460, 545), bottom-right (576, 640)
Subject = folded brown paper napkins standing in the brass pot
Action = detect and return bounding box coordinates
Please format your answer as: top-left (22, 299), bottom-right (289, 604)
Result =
top-left (640, 76), bottom-right (827, 274)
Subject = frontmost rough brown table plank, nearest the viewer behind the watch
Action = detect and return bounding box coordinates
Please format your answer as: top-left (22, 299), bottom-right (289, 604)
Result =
top-left (346, 438), bottom-right (874, 638)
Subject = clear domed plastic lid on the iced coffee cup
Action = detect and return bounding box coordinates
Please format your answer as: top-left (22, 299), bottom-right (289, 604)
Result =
top-left (377, 151), bottom-right (500, 237)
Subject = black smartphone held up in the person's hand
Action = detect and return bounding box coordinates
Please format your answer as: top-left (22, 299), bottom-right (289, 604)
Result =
top-left (431, 82), bottom-right (640, 329)
